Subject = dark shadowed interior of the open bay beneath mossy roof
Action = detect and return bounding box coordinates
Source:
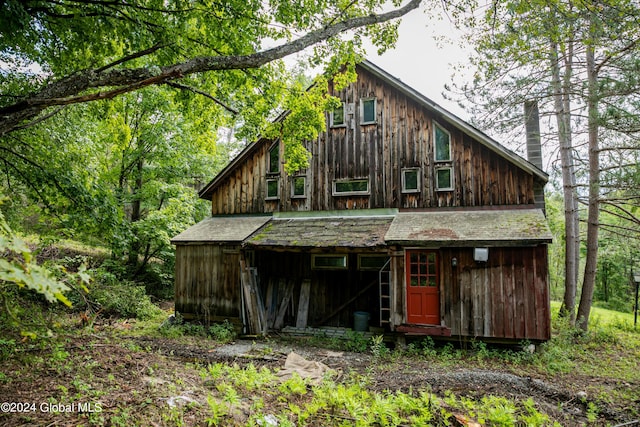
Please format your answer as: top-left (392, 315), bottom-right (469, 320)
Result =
top-left (255, 251), bottom-right (379, 327)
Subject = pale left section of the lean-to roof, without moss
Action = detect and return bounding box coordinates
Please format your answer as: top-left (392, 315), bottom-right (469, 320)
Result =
top-left (171, 215), bottom-right (271, 245)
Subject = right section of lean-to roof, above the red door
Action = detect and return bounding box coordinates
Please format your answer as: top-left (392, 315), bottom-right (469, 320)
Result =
top-left (385, 209), bottom-right (552, 247)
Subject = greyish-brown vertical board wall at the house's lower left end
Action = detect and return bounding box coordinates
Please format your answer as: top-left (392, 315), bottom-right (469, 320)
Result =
top-left (175, 245), bottom-right (240, 320)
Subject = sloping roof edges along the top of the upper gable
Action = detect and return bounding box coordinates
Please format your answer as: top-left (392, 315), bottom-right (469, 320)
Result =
top-left (198, 61), bottom-right (549, 200)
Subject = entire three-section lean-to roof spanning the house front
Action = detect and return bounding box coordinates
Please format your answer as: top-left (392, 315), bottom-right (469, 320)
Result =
top-left (171, 208), bottom-right (552, 250)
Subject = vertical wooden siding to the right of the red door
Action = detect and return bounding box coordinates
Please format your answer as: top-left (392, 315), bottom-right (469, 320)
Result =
top-left (438, 245), bottom-right (550, 340)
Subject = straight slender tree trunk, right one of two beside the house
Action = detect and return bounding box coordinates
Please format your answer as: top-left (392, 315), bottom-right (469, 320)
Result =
top-left (578, 42), bottom-right (600, 331)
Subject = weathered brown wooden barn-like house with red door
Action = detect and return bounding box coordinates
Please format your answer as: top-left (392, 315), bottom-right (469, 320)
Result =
top-left (173, 62), bottom-right (551, 340)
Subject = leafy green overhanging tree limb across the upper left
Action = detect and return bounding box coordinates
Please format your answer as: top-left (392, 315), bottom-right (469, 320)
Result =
top-left (0, 0), bottom-right (420, 139)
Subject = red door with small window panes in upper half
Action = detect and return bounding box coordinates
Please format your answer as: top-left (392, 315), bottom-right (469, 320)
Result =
top-left (406, 250), bottom-right (440, 325)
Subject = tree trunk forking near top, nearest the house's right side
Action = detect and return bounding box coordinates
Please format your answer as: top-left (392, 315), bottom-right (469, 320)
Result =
top-left (550, 41), bottom-right (580, 324)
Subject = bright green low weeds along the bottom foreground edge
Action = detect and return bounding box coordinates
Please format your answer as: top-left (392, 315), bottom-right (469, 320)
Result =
top-left (195, 363), bottom-right (559, 426)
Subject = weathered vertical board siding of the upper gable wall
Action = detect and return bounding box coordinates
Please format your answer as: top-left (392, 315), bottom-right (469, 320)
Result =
top-left (212, 66), bottom-right (534, 214)
